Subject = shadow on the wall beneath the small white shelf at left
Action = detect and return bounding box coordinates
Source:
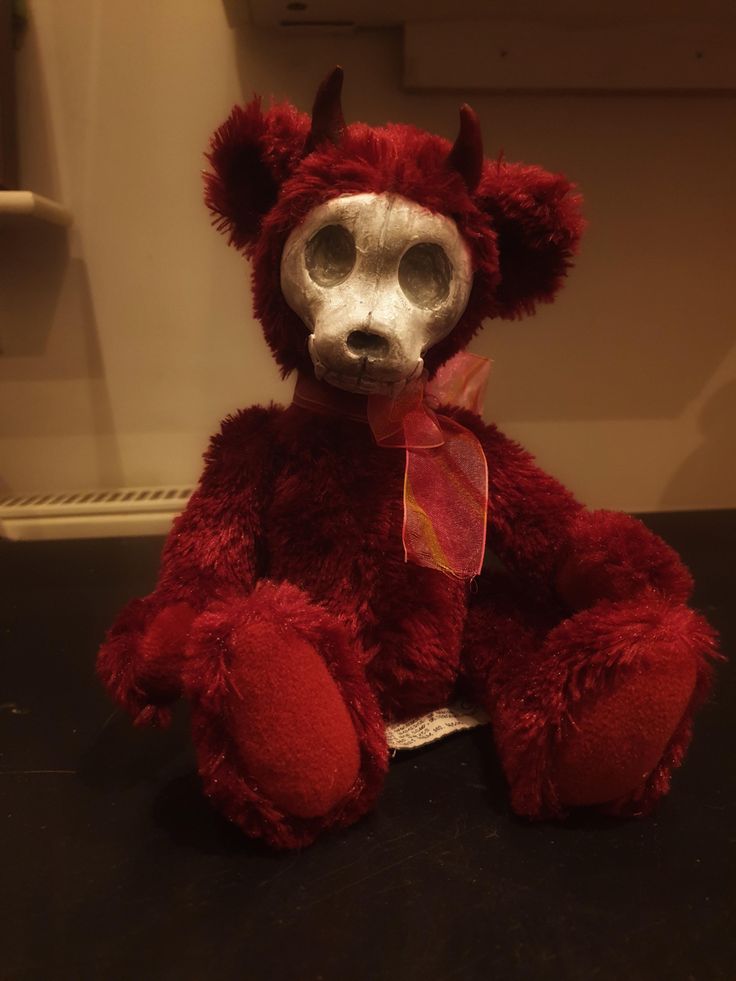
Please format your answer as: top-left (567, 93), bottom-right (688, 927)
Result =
top-left (0, 221), bottom-right (123, 490)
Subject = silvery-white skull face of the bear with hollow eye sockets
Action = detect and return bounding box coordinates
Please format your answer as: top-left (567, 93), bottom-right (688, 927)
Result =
top-left (281, 194), bottom-right (473, 396)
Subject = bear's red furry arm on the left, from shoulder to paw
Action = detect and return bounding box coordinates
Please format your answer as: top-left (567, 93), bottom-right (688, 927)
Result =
top-left (97, 406), bottom-right (282, 722)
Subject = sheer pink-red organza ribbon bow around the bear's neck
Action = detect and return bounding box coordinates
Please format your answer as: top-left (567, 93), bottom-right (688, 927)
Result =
top-left (294, 351), bottom-right (490, 579)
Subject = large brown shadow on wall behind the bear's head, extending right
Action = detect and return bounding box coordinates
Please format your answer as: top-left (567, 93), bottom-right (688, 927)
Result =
top-left (223, 6), bottom-right (736, 422)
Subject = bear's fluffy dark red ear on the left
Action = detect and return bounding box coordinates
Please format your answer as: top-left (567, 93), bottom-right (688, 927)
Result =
top-left (204, 98), bottom-right (309, 251)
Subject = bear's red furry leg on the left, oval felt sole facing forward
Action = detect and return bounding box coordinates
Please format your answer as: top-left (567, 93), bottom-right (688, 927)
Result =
top-left (184, 582), bottom-right (387, 848)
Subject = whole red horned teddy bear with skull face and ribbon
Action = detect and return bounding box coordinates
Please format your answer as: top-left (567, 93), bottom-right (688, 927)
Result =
top-left (99, 70), bottom-right (715, 848)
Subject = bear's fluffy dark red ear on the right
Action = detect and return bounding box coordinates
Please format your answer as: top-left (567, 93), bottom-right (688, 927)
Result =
top-left (474, 161), bottom-right (585, 319)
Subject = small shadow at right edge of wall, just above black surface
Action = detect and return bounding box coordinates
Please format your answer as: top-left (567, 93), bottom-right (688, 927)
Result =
top-left (660, 381), bottom-right (736, 511)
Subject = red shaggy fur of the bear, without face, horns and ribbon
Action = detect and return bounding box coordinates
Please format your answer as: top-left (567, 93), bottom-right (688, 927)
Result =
top-left (99, 86), bottom-right (715, 848)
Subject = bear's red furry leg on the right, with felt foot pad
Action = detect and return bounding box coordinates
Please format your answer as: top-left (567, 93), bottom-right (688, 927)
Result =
top-left (465, 589), bottom-right (715, 818)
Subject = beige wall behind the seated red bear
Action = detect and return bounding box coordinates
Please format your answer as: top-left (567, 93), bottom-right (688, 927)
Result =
top-left (0, 0), bottom-right (736, 510)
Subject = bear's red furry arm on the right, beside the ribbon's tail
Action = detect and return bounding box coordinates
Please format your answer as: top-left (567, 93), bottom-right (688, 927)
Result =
top-left (468, 417), bottom-right (692, 609)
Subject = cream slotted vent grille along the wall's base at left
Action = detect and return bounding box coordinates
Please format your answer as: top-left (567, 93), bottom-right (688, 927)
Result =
top-left (0, 486), bottom-right (193, 541)
